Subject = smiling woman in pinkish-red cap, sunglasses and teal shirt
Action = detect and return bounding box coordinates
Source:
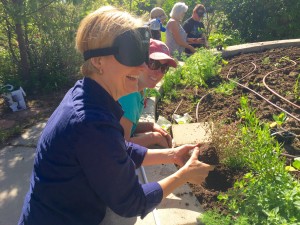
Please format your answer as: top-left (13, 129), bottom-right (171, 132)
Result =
top-left (119, 39), bottom-right (177, 148)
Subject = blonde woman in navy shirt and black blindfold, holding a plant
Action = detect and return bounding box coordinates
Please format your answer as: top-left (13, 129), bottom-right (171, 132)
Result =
top-left (19, 6), bottom-right (211, 225)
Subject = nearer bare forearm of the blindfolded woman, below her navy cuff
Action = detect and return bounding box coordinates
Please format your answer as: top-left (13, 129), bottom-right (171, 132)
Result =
top-left (158, 170), bottom-right (186, 198)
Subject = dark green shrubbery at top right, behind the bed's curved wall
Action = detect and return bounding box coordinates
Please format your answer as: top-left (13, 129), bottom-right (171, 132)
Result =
top-left (209, 0), bottom-right (300, 42)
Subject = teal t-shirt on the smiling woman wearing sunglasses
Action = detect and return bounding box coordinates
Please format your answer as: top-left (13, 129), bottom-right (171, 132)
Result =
top-left (119, 92), bottom-right (144, 136)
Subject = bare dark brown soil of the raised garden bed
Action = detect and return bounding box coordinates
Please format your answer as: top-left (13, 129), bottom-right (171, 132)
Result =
top-left (157, 47), bottom-right (300, 210)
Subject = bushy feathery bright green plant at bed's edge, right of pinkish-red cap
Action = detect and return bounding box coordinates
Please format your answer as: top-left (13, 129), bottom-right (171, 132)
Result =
top-left (181, 48), bottom-right (221, 87)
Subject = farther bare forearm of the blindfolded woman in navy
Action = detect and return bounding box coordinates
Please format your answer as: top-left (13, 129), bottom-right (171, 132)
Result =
top-left (142, 148), bottom-right (175, 166)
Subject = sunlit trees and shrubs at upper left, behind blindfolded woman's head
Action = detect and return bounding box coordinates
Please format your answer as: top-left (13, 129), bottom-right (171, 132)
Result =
top-left (0, 0), bottom-right (156, 94)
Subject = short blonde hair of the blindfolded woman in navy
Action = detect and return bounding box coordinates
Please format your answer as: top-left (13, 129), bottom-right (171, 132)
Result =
top-left (76, 6), bottom-right (143, 76)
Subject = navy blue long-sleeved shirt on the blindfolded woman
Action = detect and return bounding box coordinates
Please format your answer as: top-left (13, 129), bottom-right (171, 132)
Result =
top-left (19, 78), bottom-right (163, 225)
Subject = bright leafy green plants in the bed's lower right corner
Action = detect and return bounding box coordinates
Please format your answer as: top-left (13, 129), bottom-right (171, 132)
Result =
top-left (202, 97), bottom-right (300, 225)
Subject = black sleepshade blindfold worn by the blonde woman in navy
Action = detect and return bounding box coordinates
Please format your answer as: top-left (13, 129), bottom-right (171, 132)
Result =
top-left (83, 27), bottom-right (150, 66)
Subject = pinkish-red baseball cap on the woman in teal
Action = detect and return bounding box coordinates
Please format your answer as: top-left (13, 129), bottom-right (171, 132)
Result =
top-left (149, 38), bottom-right (177, 68)
